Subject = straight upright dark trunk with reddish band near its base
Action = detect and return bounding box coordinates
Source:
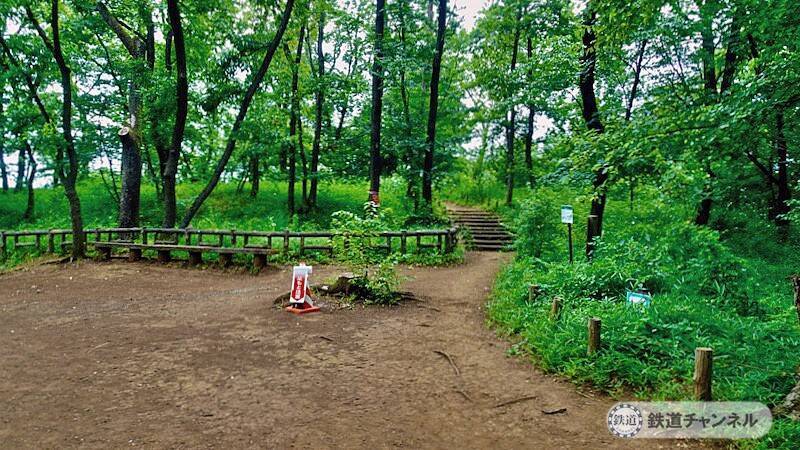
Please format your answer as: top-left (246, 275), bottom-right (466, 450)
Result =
top-left (368, 0), bottom-right (386, 203)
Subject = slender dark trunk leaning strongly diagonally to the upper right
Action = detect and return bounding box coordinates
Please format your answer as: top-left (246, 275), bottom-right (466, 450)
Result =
top-left (180, 0), bottom-right (294, 228)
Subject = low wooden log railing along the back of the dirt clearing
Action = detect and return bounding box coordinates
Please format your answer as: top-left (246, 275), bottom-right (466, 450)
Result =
top-left (0, 228), bottom-right (458, 256)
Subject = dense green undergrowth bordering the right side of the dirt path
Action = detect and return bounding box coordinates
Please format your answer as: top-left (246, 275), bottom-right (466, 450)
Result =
top-left (444, 178), bottom-right (800, 448)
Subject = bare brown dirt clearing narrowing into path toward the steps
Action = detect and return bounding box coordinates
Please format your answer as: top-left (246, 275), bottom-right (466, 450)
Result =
top-left (0, 253), bottom-right (688, 449)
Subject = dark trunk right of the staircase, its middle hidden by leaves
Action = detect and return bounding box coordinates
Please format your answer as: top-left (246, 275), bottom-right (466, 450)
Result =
top-left (580, 5), bottom-right (608, 259)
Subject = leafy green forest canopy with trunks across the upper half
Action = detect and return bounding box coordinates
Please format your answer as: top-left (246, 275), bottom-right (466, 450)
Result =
top-left (0, 0), bottom-right (800, 255)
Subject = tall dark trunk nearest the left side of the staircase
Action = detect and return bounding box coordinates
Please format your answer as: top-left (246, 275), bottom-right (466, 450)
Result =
top-left (422, 0), bottom-right (447, 209)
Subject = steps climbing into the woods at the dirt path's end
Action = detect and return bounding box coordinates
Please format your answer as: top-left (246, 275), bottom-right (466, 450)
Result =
top-left (447, 205), bottom-right (514, 252)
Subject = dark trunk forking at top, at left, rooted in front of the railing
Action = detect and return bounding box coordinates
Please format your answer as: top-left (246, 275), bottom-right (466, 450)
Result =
top-left (25, 0), bottom-right (86, 258)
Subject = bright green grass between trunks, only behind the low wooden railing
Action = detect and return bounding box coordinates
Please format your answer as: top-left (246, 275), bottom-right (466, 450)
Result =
top-left (0, 174), bottom-right (441, 230)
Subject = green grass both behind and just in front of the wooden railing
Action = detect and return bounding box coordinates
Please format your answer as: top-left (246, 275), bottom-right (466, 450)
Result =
top-left (0, 178), bottom-right (463, 268)
